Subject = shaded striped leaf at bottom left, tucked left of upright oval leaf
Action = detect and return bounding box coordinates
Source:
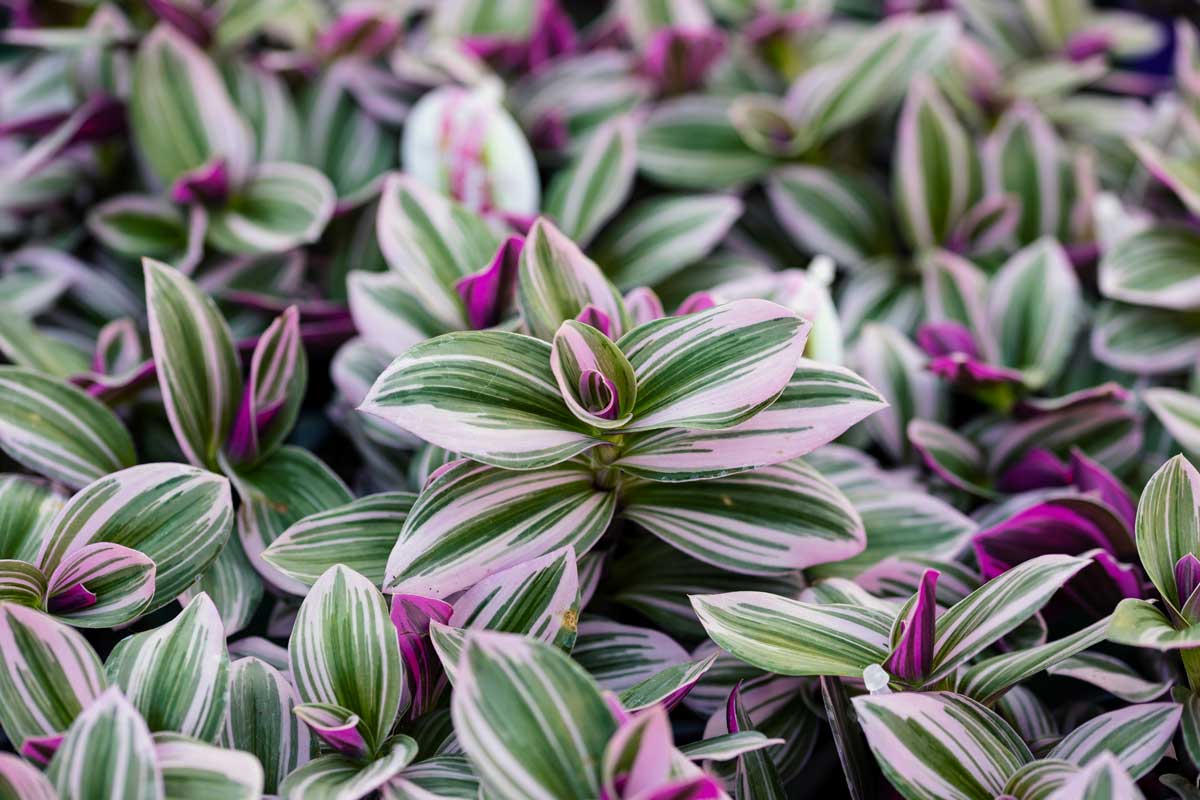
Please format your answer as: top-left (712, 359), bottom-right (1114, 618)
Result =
top-left (218, 657), bottom-right (314, 794)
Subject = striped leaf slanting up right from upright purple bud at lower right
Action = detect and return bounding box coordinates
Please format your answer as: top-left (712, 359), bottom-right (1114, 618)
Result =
top-left (926, 555), bottom-right (1091, 682)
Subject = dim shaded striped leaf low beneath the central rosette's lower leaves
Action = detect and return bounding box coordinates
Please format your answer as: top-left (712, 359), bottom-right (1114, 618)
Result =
top-left (571, 618), bottom-right (689, 692)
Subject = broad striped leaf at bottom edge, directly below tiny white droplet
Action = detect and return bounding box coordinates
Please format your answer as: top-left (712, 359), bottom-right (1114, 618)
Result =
top-left (853, 692), bottom-right (1033, 800)
